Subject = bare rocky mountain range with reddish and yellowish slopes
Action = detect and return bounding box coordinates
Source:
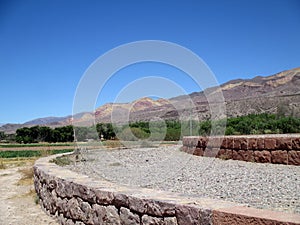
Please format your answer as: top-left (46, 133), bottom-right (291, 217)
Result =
top-left (0, 68), bottom-right (300, 132)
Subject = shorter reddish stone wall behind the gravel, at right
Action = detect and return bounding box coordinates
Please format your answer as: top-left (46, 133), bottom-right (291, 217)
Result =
top-left (182, 134), bottom-right (300, 166)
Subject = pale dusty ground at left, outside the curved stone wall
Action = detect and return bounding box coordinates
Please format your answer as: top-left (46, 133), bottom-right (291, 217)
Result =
top-left (0, 158), bottom-right (58, 225)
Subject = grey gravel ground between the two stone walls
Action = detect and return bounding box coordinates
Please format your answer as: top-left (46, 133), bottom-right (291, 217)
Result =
top-left (68, 146), bottom-right (300, 214)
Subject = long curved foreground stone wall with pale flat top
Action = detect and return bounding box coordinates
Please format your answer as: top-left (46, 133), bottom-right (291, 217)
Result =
top-left (34, 153), bottom-right (300, 225)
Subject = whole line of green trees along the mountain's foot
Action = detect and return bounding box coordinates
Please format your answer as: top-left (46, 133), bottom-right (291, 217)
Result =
top-left (0, 113), bottom-right (300, 143)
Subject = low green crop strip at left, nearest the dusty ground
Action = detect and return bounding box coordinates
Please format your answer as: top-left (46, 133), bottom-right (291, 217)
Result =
top-left (0, 149), bottom-right (73, 158)
